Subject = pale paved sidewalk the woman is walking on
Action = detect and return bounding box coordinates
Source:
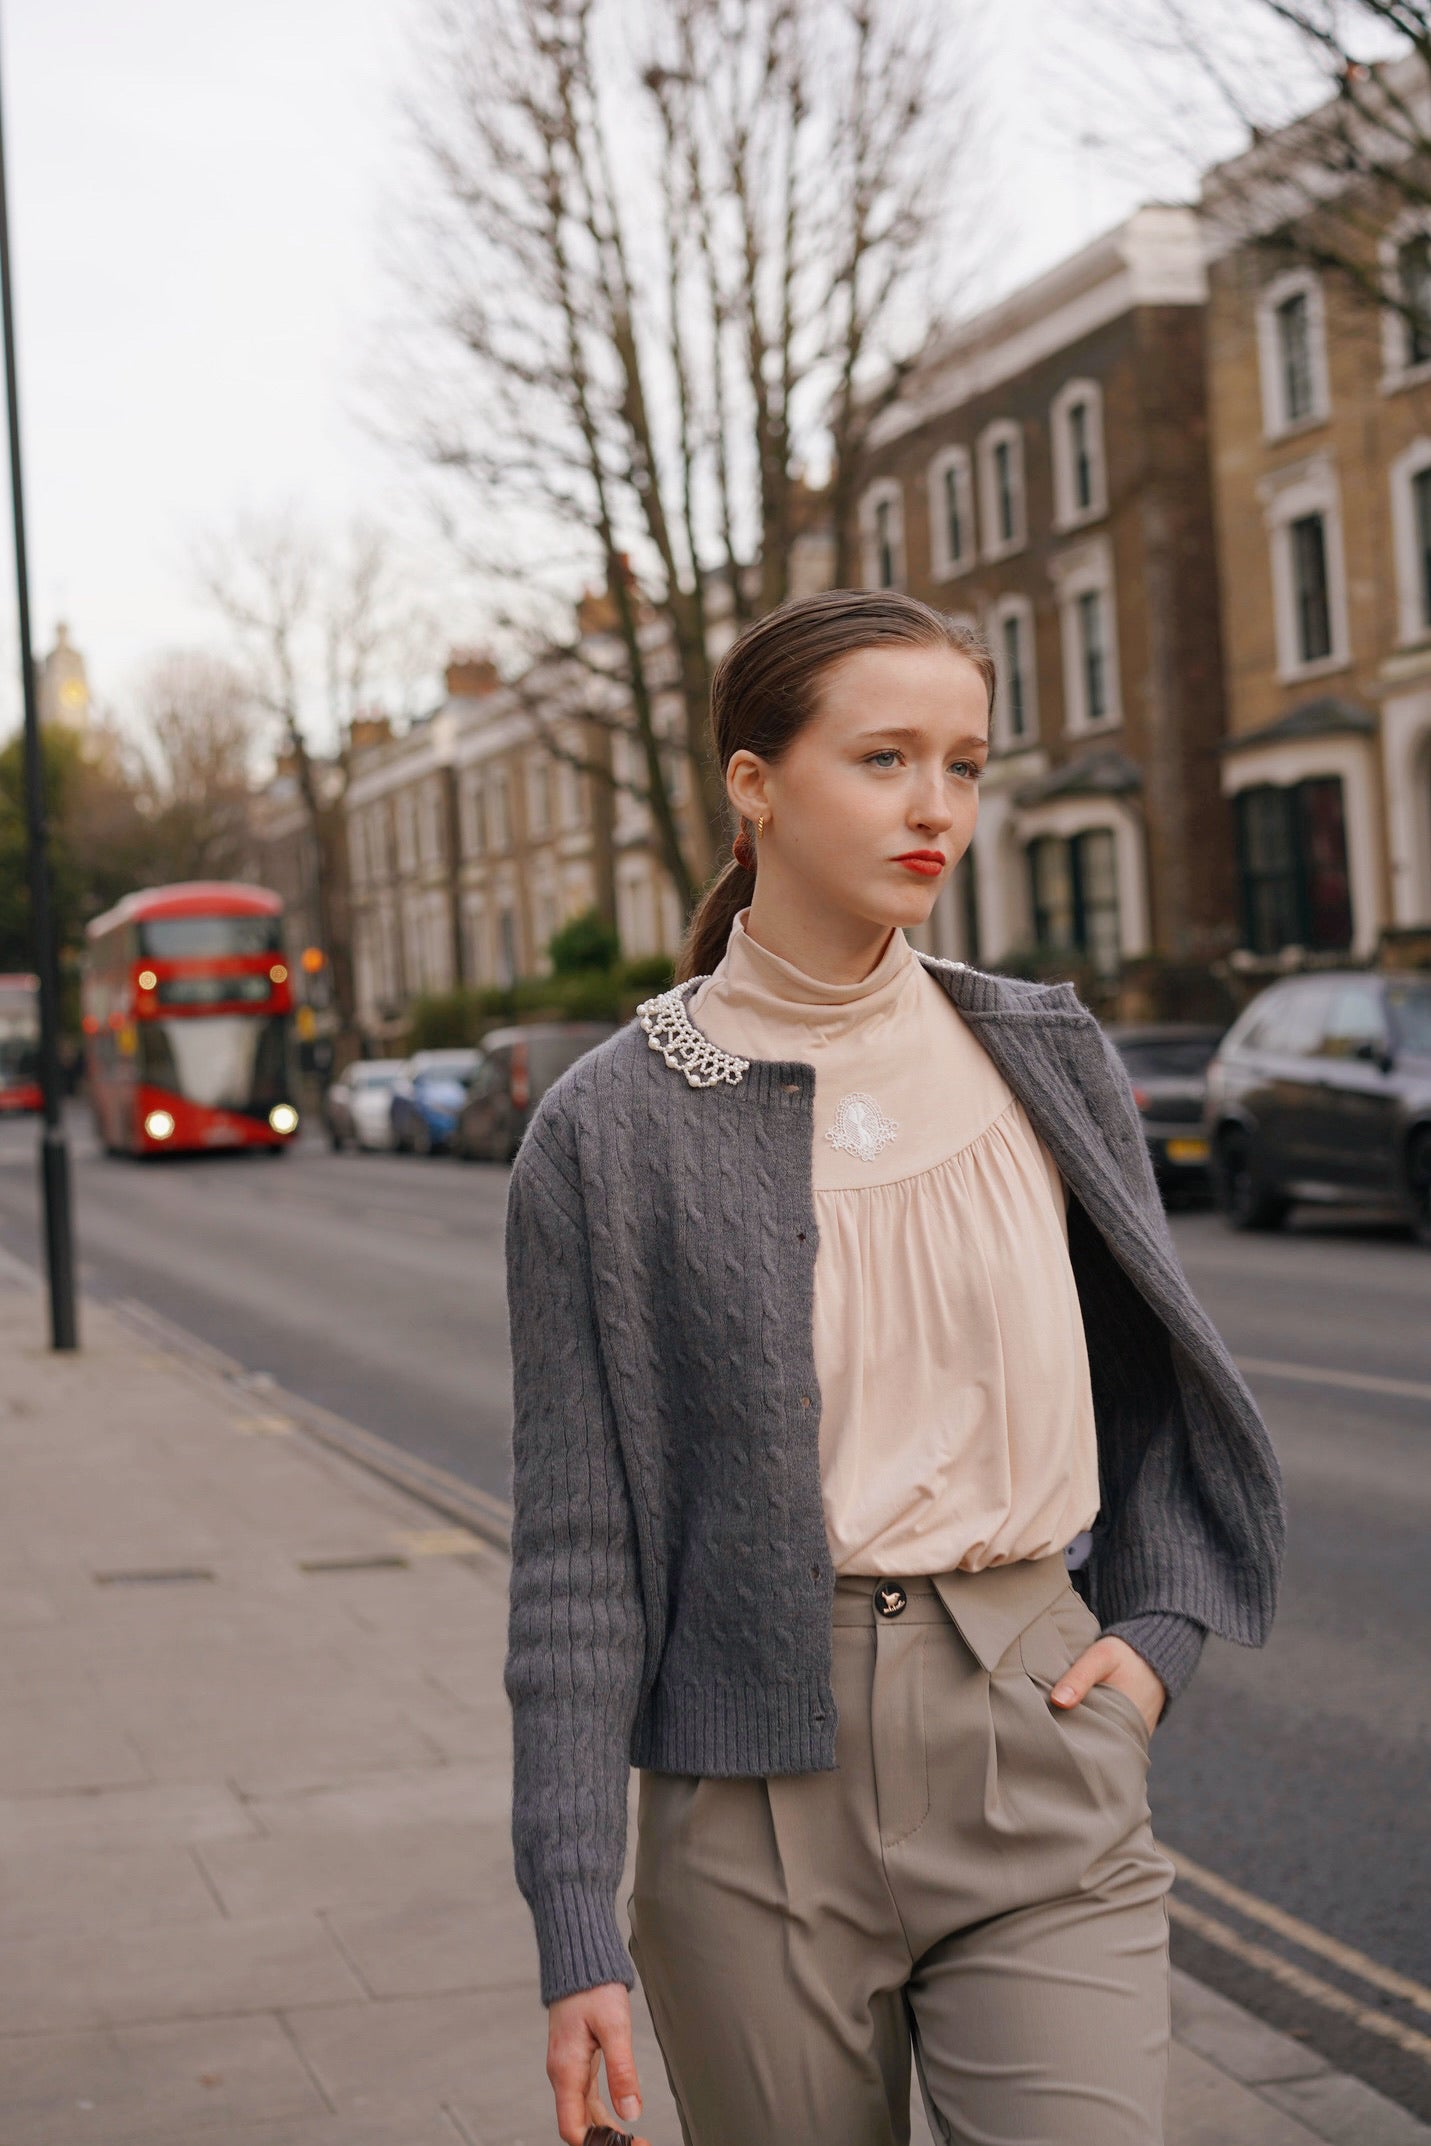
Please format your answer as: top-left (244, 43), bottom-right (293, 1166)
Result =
top-left (0, 1268), bottom-right (1431, 2146)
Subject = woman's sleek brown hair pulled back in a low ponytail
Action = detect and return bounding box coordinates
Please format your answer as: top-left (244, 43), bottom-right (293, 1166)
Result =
top-left (676, 588), bottom-right (993, 983)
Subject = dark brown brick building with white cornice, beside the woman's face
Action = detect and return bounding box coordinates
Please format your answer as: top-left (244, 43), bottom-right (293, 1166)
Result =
top-left (858, 206), bottom-right (1231, 976)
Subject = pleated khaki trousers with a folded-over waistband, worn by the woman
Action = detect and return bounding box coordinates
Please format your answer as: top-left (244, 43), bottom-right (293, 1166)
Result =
top-left (629, 1556), bottom-right (1174, 2146)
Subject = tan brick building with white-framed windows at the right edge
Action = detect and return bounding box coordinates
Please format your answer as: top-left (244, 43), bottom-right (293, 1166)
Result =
top-left (1204, 92), bottom-right (1431, 959)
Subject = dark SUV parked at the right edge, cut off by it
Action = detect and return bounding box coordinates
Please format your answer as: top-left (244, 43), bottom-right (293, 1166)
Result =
top-left (1206, 972), bottom-right (1431, 1245)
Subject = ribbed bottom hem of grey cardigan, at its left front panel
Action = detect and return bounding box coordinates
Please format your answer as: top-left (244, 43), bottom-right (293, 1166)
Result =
top-left (631, 1674), bottom-right (835, 1777)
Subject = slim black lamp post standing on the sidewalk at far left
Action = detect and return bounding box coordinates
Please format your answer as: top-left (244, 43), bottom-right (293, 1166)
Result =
top-left (0, 8), bottom-right (79, 1348)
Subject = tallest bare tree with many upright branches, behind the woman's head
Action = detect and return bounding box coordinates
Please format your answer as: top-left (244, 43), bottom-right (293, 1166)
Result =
top-left (392, 0), bottom-right (995, 903)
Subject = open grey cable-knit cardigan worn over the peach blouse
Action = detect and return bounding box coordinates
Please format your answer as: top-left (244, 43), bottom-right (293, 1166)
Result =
top-left (504, 955), bottom-right (1283, 2004)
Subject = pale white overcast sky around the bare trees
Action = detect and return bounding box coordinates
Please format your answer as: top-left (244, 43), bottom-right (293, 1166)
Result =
top-left (0, 0), bottom-right (1184, 727)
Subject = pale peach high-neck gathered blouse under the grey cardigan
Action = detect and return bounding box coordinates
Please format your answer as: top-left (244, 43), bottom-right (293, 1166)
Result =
top-left (689, 910), bottom-right (1098, 1575)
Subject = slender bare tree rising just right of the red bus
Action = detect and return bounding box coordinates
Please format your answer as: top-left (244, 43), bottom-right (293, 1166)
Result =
top-left (195, 513), bottom-right (436, 1028)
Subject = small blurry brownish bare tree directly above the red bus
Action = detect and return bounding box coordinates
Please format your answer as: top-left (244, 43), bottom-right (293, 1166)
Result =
top-left (137, 650), bottom-right (255, 880)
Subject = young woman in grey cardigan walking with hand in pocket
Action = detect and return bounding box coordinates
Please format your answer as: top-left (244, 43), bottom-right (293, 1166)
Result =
top-left (506, 590), bottom-right (1283, 2146)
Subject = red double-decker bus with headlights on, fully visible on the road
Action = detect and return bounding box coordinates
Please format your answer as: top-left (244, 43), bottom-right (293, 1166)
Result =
top-left (82, 880), bottom-right (298, 1155)
